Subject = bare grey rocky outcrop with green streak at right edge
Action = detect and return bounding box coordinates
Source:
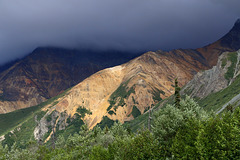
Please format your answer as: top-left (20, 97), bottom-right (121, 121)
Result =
top-left (182, 50), bottom-right (240, 98)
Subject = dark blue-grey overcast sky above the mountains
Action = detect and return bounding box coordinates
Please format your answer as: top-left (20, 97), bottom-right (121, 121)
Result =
top-left (0, 0), bottom-right (240, 64)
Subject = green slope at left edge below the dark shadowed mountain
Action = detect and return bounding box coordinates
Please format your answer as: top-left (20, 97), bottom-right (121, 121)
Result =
top-left (0, 87), bottom-right (73, 148)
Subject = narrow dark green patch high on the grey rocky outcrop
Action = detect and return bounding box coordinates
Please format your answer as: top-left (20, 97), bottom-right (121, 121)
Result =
top-left (224, 52), bottom-right (237, 80)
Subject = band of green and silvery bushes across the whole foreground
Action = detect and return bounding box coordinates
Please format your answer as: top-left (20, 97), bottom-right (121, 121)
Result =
top-left (0, 97), bottom-right (240, 160)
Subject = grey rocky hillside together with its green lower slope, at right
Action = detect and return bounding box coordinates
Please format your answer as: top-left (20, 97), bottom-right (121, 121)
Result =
top-left (182, 50), bottom-right (240, 113)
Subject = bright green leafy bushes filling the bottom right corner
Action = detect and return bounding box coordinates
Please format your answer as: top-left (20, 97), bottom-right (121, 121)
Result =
top-left (171, 108), bottom-right (240, 159)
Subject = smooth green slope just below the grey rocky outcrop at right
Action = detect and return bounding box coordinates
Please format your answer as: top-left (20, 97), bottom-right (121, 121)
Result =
top-left (198, 75), bottom-right (240, 111)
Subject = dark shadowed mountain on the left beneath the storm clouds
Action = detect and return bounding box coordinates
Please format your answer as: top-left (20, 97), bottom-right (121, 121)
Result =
top-left (0, 47), bottom-right (139, 113)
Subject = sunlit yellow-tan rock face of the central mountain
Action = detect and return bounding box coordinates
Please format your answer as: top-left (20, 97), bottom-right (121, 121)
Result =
top-left (45, 50), bottom-right (210, 128)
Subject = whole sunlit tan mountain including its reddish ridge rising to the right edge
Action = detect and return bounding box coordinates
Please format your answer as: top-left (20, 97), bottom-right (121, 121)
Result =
top-left (0, 21), bottom-right (240, 145)
